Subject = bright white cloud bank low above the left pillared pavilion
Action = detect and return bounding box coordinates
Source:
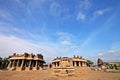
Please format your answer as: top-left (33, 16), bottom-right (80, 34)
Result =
top-left (0, 34), bottom-right (59, 61)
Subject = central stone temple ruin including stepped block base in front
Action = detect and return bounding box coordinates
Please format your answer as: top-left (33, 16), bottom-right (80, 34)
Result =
top-left (52, 56), bottom-right (86, 76)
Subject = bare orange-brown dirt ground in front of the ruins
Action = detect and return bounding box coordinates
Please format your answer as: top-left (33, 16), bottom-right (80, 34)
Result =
top-left (0, 68), bottom-right (120, 80)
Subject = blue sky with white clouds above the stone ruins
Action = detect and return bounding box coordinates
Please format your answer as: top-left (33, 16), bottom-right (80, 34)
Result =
top-left (0, 0), bottom-right (120, 62)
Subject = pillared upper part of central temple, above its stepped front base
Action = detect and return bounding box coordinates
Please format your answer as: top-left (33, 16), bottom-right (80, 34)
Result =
top-left (52, 55), bottom-right (87, 67)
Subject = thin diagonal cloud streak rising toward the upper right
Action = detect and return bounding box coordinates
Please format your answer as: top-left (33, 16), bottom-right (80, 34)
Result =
top-left (77, 8), bottom-right (117, 49)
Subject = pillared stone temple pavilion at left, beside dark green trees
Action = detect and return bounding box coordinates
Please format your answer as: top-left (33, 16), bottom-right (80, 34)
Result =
top-left (7, 53), bottom-right (45, 71)
